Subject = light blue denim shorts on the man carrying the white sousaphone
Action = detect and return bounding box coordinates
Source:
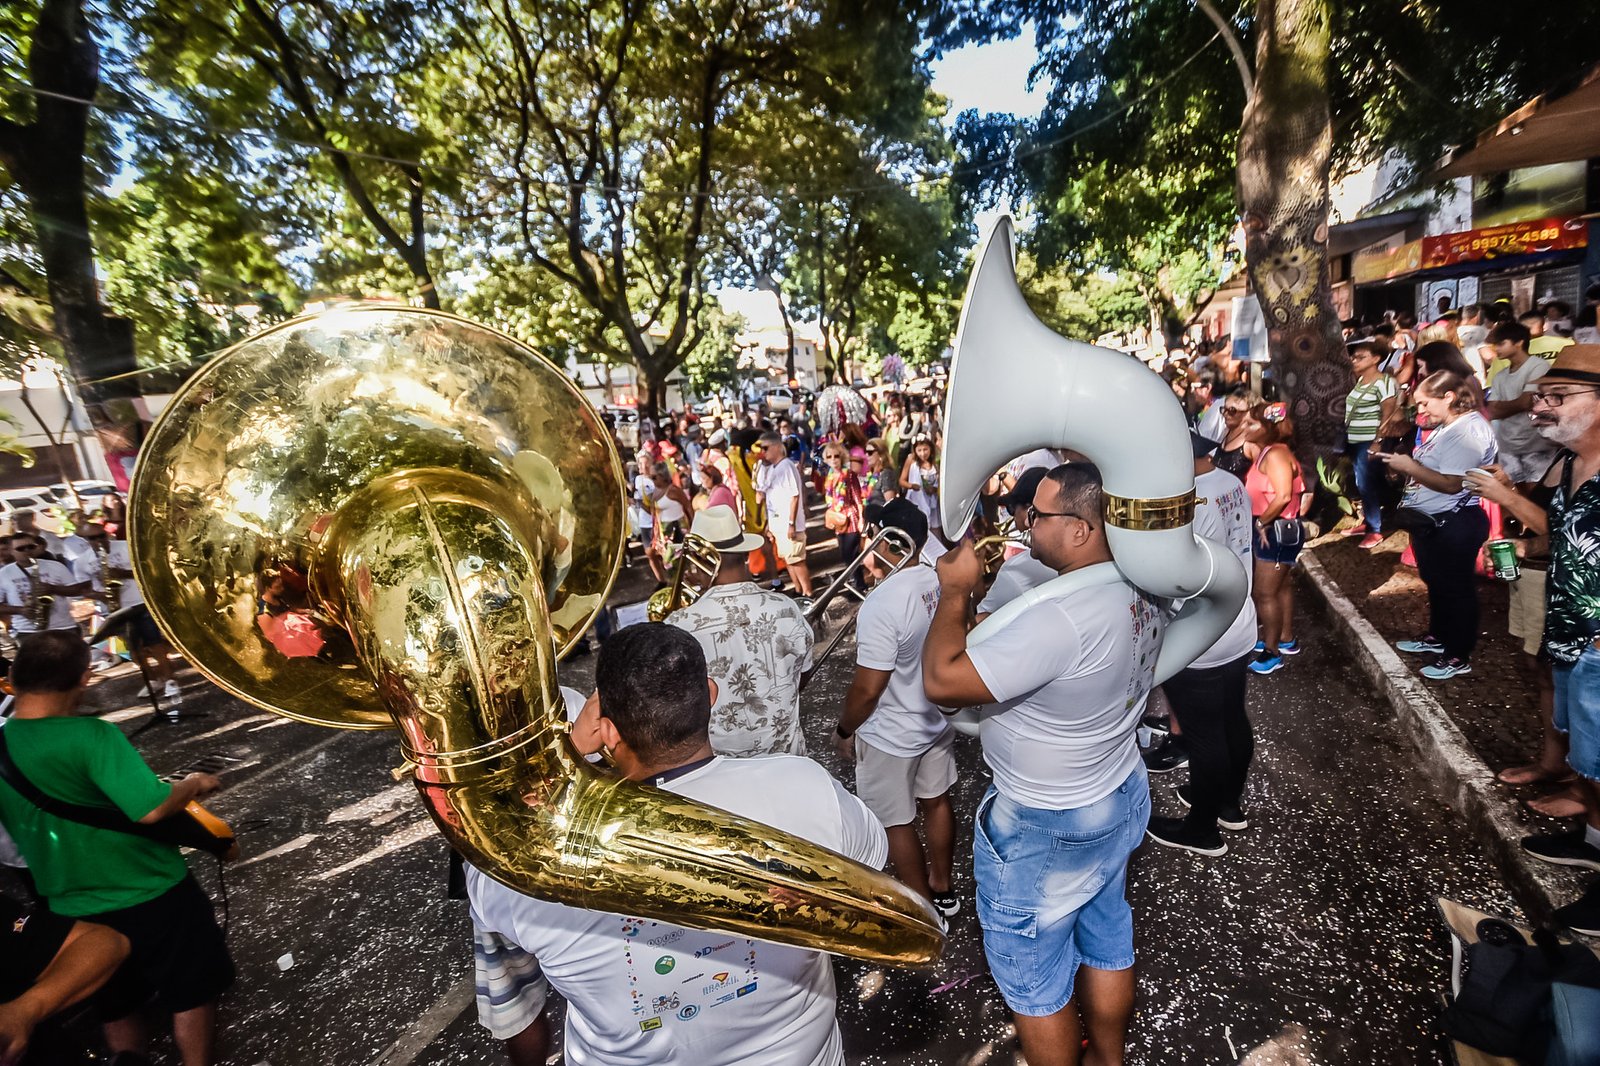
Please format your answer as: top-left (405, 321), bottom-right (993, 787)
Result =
top-left (973, 765), bottom-right (1150, 1016)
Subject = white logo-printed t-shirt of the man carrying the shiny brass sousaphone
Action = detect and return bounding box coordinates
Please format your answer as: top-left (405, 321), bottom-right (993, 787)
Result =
top-left (467, 745), bottom-right (888, 1066)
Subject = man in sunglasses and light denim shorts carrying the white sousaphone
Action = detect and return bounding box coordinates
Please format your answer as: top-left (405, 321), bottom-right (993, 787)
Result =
top-left (923, 463), bottom-right (1166, 1061)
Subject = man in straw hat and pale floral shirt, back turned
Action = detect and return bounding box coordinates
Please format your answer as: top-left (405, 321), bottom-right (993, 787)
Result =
top-left (666, 507), bottom-right (816, 757)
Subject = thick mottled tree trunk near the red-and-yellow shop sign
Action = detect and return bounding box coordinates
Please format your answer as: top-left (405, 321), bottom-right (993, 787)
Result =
top-left (1238, 0), bottom-right (1352, 458)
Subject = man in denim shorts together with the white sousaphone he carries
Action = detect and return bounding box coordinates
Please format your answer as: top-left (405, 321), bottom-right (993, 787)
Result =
top-left (923, 219), bottom-right (1245, 1066)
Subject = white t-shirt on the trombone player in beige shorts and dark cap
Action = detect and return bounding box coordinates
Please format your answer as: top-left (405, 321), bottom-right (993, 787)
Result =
top-left (856, 565), bottom-right (950, 759)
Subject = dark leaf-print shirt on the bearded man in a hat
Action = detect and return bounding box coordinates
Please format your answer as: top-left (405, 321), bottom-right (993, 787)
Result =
top-left (1544, 464), bottom-right (1600, 663)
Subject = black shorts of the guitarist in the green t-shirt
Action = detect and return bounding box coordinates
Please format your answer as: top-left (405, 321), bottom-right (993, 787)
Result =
top-left (85, 876), bottom-right (234, 1021)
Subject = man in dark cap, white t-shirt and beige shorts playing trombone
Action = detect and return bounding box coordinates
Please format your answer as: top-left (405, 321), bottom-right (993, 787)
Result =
top-left (834, 499), bottom-right (962, 917)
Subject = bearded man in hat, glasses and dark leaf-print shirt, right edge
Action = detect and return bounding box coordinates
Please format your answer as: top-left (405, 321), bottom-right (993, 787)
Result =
top-left (1467, 344), bottom-right (1600, 935)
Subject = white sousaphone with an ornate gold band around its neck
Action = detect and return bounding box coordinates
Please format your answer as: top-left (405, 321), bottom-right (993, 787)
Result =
top-left (939, 218), bottom-right (1248, 731)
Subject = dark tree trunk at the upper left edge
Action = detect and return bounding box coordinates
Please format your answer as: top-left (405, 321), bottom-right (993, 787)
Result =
top-left (0, 0), bottom-right (138, 437)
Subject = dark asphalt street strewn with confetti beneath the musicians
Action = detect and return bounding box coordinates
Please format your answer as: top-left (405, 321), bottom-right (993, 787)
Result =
top-left (5, 567), bottom-right (1512, 1066)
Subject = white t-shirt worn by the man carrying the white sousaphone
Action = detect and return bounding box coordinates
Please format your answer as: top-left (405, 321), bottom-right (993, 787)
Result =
top-left (966, 562), bottom-right (1166, 810)
